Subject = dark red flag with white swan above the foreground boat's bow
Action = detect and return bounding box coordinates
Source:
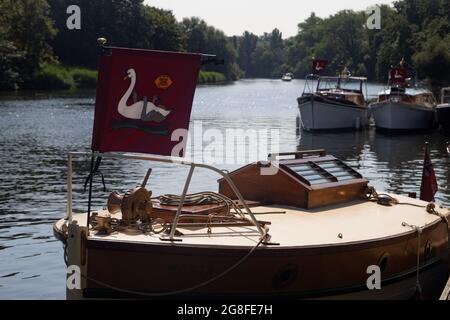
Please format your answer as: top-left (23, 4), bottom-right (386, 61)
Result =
top-left (92, 47), bottom-right (202, 156)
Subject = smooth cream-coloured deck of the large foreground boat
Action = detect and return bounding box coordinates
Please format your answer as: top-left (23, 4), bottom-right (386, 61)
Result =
top-left (56, 196), bottom-right (450, 248)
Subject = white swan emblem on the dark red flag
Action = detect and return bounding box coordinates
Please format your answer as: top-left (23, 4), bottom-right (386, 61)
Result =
top-left (118, 69), bottom-right (172, 123)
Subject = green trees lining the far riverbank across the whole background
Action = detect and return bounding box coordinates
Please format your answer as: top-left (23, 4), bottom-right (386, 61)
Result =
top-left (0, 0), bottom-right (450, 90)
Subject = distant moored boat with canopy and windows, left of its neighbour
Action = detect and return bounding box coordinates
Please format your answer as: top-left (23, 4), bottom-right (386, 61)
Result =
top-left (297, 76), bottom-right (368, 131)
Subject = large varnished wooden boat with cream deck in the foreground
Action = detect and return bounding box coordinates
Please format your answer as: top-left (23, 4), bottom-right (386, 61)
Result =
top-left (54, 150), bottom-right (450, 299)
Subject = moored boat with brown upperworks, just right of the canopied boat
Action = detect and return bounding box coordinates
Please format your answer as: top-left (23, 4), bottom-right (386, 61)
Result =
top-left (370, 67), bottom-right (437, 131)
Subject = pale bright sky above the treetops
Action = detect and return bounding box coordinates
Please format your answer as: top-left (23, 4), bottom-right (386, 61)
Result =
top-left (145, 0), bottom-right (393, 38)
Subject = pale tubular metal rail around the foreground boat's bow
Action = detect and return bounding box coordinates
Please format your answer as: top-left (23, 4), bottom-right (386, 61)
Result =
top-left (65, 152), bottom-right (268, 241)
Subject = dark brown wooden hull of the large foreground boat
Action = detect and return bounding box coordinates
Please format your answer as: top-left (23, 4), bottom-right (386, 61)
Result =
top-left (54, 215), bottom-right (449, 300)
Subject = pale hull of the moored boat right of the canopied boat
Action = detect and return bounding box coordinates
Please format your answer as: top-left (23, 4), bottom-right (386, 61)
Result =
top-left (370, 101), bottom-right (436, 131)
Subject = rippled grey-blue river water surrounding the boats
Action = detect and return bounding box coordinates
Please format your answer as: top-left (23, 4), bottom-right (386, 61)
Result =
top-left (0, 80), bottom-right (450, 299)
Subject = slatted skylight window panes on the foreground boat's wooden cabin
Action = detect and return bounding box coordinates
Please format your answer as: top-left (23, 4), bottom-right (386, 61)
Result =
top-left (288, 160), bottom-right (362, 186)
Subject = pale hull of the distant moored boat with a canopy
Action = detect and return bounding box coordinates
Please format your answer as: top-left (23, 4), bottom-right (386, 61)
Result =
top-left (298, 96), bottom-right (368, 131)
